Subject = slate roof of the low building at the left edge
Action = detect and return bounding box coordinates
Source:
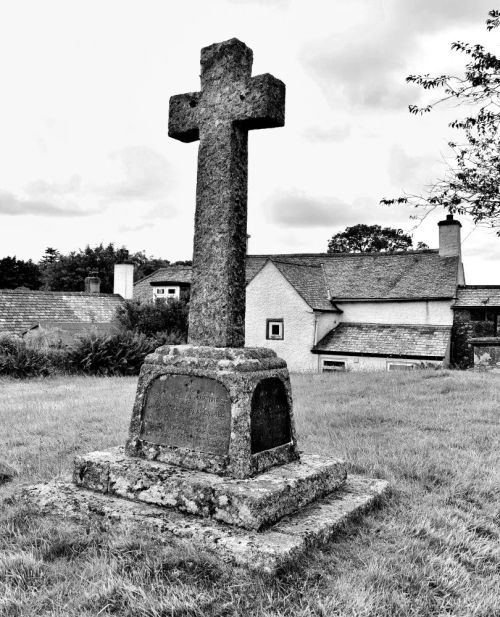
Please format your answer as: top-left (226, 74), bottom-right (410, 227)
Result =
top-left (0, 289), bottom-right (123, 334)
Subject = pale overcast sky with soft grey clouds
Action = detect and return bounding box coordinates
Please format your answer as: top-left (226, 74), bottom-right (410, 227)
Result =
top-left (0, 0), bottom-right (500, 284)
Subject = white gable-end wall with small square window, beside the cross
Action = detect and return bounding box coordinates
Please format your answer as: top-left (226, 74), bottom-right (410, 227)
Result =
top-left (245, 262), bottom-right (318, 371)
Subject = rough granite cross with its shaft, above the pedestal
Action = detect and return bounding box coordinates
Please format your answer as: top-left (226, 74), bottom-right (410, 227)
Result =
top-left (168, 39), bottom-right (285, 347)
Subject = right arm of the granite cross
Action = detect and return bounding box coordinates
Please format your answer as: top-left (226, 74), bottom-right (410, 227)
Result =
top-left (236, 73), bottom-right (285, 129)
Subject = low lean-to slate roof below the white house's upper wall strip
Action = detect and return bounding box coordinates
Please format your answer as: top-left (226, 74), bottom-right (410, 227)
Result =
top-left (313, 323), bottom-right (451, 359)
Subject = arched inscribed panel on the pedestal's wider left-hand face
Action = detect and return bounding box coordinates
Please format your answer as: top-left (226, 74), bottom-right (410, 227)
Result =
top-left (140, 375), bottom-right (231, 455)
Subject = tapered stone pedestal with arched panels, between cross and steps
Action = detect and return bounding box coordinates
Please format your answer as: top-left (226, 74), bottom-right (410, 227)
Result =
top-left (126, 345), bottom-right (299, 478)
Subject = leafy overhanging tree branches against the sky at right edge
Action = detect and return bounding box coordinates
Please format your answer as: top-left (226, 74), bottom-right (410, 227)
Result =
top-left (381, 10), bottom-right (500, 235)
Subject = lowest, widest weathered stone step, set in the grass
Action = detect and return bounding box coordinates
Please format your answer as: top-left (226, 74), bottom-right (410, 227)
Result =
top-left (22, 476), bottom-right (388, 573)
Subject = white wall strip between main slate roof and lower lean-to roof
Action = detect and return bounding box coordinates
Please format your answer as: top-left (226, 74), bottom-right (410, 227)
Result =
top-left (336, 300), bottom-right (453, 326)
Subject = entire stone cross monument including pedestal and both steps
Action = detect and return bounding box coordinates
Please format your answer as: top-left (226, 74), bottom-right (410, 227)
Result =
top-left (25, 39), bottom-right (387, 572)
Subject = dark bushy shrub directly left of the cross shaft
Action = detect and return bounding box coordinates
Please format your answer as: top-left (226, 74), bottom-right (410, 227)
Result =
top-left (117, 299), bottom-right (188, 343)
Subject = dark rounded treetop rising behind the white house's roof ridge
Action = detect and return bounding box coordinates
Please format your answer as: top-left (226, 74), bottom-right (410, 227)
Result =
top-left (328, 224), bottom-right (428, 253)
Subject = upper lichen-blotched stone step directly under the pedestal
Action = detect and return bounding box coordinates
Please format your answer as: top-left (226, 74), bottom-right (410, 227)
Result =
top-left (73, 448), bottom-right (347, 530)
